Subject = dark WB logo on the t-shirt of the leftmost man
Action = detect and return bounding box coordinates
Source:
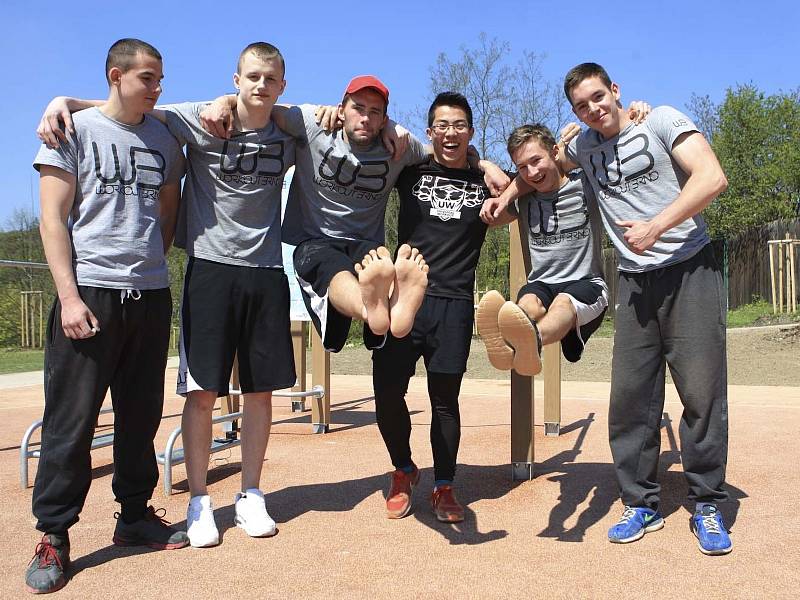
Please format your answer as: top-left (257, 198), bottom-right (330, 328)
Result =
top-left (92, 142), bottom-right (167, 199)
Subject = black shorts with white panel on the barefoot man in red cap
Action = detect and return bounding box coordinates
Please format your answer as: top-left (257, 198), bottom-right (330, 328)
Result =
top-left (294, 238), bottom-right (382, 352)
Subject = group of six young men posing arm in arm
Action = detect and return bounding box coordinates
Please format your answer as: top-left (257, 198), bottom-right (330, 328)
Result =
top-left (26, 39), bottom-right (731, 593)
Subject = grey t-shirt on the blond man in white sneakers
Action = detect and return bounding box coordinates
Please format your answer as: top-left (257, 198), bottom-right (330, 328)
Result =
top-left (164, 102), bottom-right (295, 268)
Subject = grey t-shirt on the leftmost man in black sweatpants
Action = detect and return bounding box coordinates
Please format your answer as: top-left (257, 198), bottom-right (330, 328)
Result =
top-left (33, 108), bottom-right (184, 290)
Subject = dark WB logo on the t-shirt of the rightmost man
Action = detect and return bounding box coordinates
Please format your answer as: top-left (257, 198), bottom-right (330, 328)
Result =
top-left (589, 133), bottom-right (658, 193)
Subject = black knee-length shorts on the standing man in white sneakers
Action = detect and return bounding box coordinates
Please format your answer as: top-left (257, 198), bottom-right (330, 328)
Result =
top-left (178, 257), bottom-right (296, 396)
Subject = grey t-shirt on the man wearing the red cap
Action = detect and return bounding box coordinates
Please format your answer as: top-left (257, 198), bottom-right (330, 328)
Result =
top-left (283, 104), bottom-right (427, 245)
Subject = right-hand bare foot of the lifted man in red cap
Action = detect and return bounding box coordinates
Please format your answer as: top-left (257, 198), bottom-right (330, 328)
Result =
top-left (389, 244), bottom-right (428, 338)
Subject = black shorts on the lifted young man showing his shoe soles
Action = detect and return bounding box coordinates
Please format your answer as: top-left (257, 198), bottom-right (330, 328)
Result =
top-left (517, 277), bottom-right (608, 362)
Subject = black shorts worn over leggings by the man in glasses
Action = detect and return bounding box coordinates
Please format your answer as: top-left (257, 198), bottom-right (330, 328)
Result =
top-left (372, 295), bottom-right (474, 379)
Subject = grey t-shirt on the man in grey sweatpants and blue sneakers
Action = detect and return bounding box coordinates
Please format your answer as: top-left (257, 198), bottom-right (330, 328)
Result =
top-left (567, 106), bottom-right (709, 272)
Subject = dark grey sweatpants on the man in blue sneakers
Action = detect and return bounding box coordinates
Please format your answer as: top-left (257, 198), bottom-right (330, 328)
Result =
top-left (608, 244), bottom-right (728, 509)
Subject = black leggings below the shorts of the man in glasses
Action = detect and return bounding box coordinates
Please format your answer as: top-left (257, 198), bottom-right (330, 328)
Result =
top-left (372, 368), bottom-right (463, 481)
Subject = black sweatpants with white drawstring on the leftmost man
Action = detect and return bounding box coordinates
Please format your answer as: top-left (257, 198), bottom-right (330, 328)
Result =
top-left (33, 286), bottom-right (172, 532)
